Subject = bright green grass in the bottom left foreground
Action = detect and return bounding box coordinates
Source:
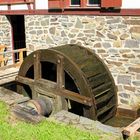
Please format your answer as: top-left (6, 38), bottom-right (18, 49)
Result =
top-left (0, 102), bottom-right (99, 140)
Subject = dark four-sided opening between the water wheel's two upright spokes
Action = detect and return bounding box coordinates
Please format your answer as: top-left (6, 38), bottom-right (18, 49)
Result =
top-left (41, 61), bottom-right (57, 82)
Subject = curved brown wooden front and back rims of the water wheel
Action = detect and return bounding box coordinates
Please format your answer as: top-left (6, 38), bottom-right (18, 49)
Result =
top-left (19, 45), bottom-right (117, 121)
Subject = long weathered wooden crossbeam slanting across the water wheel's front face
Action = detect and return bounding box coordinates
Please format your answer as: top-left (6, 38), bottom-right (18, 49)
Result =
top-left (16, 76), bottom-right (93, 106)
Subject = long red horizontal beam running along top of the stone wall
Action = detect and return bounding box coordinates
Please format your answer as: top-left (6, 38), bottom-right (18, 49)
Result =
top-left (0, 8), bottom-right (140, 16)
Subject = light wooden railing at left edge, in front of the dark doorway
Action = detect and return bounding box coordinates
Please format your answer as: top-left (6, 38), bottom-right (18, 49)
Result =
top-left (0, 48), bottom-right (27, 67)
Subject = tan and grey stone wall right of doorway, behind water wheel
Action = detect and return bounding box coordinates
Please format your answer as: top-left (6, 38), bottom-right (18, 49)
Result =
top-left (25, 15), bottom-right (140, 106)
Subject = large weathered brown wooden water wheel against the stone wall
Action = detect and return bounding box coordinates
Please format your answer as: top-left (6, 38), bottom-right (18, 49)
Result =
top-left (16, 45), bottom-right (117, 122)
